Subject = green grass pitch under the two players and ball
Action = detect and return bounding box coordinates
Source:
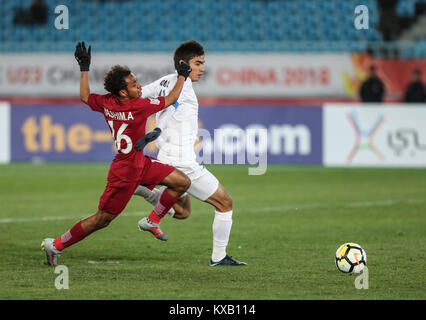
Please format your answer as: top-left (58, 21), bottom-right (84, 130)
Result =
top-left (0, 163), bottom-right (426, 300)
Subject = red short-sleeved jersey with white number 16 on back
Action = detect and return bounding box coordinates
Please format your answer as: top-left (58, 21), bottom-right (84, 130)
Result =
top-left (88, 93), bottom-right (165, 182)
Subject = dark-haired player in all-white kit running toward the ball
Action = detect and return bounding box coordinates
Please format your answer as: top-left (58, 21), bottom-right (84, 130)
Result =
top-left (135, 40), bottom-right (246, 266)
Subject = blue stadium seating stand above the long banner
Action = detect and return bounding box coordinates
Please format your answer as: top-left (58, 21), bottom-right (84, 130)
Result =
top-left (0, 0), bottom-right (426, 58)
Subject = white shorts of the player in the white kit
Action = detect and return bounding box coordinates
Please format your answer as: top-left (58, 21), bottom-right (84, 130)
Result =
top-left (174, 163), bottom-right (219, 201)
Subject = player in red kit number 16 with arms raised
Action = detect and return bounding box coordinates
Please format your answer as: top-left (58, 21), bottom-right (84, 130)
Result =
top-left (42, 42), bottom-right (191, 265)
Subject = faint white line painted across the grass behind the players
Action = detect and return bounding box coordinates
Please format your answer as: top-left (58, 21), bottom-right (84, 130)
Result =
top-left (0, 199), bottom-right (426, 224)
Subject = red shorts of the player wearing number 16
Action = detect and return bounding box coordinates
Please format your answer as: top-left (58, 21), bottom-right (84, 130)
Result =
top-left (98, 156), bottom-right (176, 215)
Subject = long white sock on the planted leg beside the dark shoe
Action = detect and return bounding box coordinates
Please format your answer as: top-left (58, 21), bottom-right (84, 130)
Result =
top-left (212, 210), bottom-right (232, 262)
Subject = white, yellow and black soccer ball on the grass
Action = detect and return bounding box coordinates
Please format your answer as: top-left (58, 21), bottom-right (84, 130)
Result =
top-left (335, 242), bottom-right (367, 273)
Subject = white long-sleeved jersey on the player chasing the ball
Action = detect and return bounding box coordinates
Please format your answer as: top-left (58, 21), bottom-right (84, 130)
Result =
top-left (142, 73), bottom-right (198, 166)
